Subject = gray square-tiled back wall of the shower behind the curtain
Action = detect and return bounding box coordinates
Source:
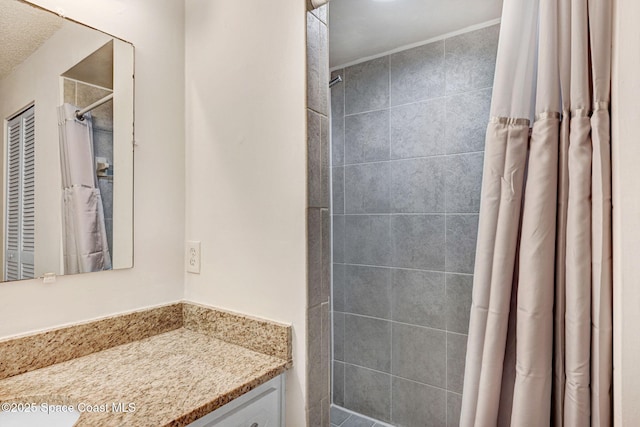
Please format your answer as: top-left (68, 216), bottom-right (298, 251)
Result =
top-left (331, 26), bottom-right (498, 426)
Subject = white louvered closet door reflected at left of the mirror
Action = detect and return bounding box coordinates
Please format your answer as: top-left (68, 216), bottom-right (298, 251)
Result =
top-left (3, 106), bottom-right (35, 280)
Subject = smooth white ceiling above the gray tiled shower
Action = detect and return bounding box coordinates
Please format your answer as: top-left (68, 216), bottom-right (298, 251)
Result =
top-left (329, 0), bottom-right (502, 67)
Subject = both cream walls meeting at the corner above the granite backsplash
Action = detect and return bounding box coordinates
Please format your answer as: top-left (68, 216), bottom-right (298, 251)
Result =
top-left (0, 0), bottom-right (306, 426)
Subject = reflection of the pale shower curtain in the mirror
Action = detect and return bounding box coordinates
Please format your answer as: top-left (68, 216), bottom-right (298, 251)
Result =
top-left (58, 104), bottom-right (111, 274)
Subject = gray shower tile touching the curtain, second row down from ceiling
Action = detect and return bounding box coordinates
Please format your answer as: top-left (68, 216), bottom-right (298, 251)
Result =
top-left (446, 88), bottom-right (492, 154)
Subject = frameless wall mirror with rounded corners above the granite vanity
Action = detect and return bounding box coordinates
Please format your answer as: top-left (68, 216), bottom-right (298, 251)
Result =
top-left (0, 0), bottom-right (134, 281)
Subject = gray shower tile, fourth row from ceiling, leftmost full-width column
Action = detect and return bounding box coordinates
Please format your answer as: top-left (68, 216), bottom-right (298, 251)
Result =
top-left (345, 215), bottom-right (391, 266)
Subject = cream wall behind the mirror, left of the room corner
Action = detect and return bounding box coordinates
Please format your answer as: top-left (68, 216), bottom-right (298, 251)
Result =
top-left (0, 0), bottom-right (185, 338)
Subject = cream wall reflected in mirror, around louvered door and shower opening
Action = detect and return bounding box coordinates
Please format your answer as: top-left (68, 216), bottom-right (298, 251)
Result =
top-left (0, 22), bottom-right (111, 276)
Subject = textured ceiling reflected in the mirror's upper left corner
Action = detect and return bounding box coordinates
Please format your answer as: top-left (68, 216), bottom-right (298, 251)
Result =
top-left (0, 0), bottom-right (64, 79)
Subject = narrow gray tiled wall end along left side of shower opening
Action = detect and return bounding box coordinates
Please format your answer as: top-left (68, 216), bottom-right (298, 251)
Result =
top-left (306, 6), bottom-right (331, 427)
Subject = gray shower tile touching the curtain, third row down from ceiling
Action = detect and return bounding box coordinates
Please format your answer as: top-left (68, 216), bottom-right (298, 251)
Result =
top-left (444, 152), bottom-right (484, 213)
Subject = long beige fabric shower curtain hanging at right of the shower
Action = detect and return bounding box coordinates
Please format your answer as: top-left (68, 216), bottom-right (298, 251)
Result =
top-left (460, 0), bottom-right (612, 427)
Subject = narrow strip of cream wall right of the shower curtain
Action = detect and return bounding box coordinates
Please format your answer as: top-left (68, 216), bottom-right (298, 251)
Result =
top-left (611, 0), bottom-right (640, 427)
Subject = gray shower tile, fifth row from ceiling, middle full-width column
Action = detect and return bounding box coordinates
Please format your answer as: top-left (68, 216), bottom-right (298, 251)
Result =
top-left (391, 269), bottom-right (446, 329)
